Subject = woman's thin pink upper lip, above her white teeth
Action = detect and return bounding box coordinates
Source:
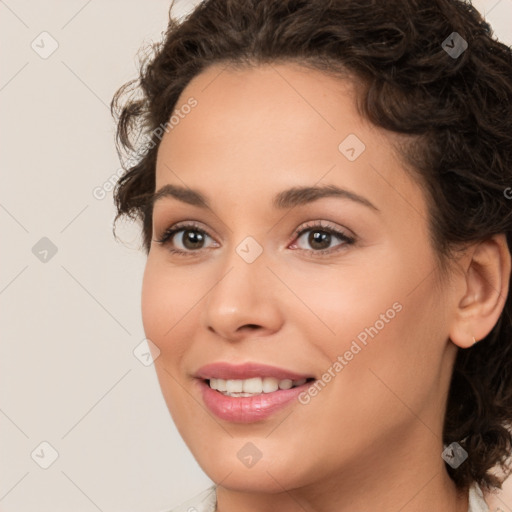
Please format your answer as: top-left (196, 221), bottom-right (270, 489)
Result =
top-left (195, 362), bottom-right (313, 380)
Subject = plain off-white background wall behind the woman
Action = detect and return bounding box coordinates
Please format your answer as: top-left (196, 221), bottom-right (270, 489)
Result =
top-left (0, 0), bottom-right (512, 512)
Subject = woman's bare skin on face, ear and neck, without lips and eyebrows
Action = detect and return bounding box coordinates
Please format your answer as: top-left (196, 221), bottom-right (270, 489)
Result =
top-left (142, 63), bottom-right (510, 512)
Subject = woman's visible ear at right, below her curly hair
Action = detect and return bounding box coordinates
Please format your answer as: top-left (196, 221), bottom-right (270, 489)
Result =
top-left (450, 233), bottom-right (511, 348)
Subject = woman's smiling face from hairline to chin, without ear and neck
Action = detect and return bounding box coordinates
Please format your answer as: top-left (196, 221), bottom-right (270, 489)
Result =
top-left (142, 64), bottom-right (456, 492)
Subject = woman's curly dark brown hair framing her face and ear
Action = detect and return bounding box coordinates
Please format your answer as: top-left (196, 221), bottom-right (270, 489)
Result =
top-left (111, 0), bottom-right (512, 496)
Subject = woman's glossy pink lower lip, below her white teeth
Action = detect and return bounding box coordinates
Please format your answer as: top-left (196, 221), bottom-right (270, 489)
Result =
top-left (199, 380), bottom-right (313, 423)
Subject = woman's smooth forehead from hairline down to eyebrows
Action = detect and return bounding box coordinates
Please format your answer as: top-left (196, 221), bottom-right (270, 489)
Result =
top-left (156, 63), bottom-right (430, 224)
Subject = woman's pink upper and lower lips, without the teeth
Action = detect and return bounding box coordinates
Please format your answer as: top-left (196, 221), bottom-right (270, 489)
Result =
top-left (195, 362), bottom-right (312, 423)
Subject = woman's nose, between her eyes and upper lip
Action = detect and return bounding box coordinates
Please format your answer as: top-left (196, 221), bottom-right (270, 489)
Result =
top-left (201, 244), bottom-right (285, 341)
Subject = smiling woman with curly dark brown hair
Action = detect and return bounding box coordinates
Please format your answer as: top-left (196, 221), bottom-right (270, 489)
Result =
top-left (112, 0), bottom-right (512, 512)
